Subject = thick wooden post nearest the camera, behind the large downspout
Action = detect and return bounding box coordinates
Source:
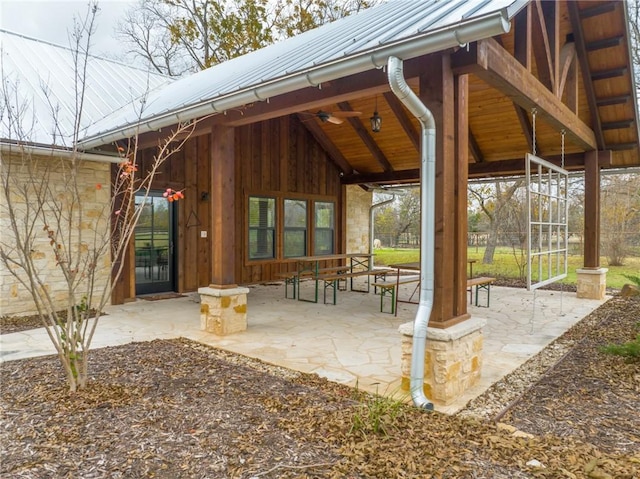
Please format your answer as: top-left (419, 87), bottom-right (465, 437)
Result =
top-left (420, 55), bottom-right (469, 328)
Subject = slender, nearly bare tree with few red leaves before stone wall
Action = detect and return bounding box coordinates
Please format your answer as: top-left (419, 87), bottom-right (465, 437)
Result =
top-left (0, 4), bottom-right (200, 391)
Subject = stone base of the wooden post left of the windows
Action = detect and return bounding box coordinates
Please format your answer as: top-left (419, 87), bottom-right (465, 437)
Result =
top-left (198, 287), bottom-right (249, 336)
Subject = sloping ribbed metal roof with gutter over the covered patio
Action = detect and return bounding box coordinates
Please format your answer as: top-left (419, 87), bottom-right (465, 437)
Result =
top-left (81, 0), bottom-right (528, 147)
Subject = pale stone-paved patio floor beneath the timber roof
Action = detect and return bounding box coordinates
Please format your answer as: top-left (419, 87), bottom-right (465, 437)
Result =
top-left (0, 283), bottom-right (604, 413)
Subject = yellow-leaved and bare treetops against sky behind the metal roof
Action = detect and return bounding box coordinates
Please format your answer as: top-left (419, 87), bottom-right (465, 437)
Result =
top-left (117, 0), bottom-right (379, 76)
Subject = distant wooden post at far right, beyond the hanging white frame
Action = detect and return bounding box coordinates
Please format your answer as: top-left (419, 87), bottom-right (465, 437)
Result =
top-left (584, 151), bottom-right (600, 269)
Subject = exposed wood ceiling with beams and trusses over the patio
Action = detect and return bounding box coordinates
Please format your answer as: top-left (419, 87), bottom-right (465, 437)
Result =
top-left (196, 0), bottom-right (640, 185)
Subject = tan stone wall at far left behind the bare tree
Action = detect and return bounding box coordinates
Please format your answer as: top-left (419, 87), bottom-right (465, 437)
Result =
top-left (0, 154), bottom-right (111, 316)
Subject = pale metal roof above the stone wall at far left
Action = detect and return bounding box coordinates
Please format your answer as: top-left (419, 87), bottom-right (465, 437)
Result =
top-left (0, 29), bottom-right (172, 148)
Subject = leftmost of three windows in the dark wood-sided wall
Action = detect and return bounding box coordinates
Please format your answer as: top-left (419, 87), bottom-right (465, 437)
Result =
top-left (249, 196), bottom-right (276, 259)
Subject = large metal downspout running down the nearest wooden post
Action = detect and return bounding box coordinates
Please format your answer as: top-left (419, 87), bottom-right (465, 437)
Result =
top-left (388, 56), bottom-right (436, 410)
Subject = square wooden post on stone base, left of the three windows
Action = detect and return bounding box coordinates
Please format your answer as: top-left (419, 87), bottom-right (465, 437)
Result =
top-left (210, 125), bottom-right (238, 289)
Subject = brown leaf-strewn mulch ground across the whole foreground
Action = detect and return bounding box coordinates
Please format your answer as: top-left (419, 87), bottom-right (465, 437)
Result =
top-left (0, 298), bottom-right (640, 478)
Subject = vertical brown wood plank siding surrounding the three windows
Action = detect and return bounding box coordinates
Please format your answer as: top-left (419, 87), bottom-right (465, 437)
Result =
top-left (235, 117), bottom-right (343, 284)
